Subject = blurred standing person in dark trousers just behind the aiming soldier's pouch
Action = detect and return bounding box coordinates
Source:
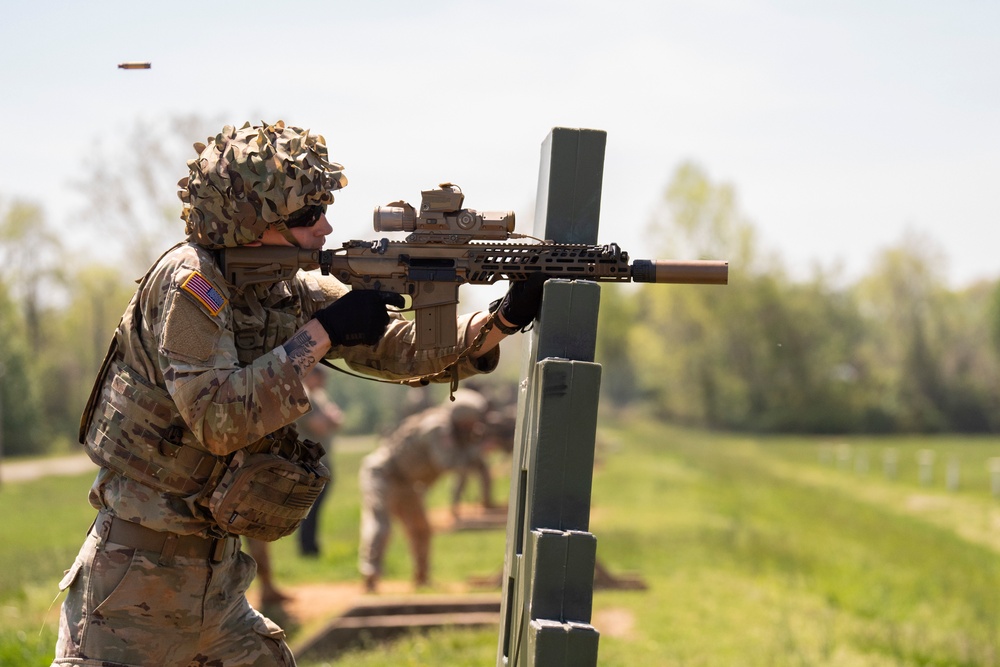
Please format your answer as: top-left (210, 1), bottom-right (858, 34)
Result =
top-left (297, 366), bottom-right (344, 558)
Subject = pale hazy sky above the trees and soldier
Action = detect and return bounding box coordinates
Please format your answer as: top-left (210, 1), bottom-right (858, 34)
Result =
top-left (0, 0), bottom-right (1000, 284)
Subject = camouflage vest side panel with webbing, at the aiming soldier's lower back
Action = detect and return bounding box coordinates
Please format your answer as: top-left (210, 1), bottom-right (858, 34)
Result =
top-left (83, 359), bottom-right (223, 496)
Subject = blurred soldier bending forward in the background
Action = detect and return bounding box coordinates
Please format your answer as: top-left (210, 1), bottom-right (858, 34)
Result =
top-left (358, 389), bottom-right (508, 592)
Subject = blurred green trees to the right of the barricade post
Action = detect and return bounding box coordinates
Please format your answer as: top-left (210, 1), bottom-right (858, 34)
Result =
top-left (599, 164), bottom-right (1000, 433)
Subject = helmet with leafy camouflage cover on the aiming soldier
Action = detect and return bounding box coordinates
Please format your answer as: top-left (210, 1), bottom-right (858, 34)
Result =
top-left (177, 120), bottom-right (347, 248)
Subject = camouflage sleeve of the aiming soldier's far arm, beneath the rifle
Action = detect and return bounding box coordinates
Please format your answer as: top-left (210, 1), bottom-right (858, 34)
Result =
top-left (299, 272), bottom-right (500, 380)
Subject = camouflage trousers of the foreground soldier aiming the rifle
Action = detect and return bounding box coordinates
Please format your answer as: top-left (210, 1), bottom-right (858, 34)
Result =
top-left (52, 529), bottom-right (295, 667)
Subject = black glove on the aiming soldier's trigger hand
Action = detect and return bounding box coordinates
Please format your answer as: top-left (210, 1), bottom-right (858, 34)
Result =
top-left (313, 290), bottom-right (406, 346)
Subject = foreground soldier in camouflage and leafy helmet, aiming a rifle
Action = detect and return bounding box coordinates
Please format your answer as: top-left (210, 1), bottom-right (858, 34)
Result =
top-left (53, 121), bottom-right (541, 667)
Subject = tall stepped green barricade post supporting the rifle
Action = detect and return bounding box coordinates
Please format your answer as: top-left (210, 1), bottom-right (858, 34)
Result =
top-left (497, 128), bottom-right (607, 667)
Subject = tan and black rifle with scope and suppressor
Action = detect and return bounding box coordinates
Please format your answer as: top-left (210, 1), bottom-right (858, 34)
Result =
top-left (220, 183), bottom-right (729, 350)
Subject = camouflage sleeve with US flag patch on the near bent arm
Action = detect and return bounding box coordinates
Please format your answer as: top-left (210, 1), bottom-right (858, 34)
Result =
top-left (142, 245), bottom-right (309, 455)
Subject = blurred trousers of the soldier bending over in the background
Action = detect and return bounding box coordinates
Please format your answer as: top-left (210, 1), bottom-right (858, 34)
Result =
top-left (358, 460), bottom-right (432, 585)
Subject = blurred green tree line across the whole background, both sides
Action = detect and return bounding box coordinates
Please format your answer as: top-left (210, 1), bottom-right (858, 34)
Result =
top-left (0, 159), bottom-right (1000, 455)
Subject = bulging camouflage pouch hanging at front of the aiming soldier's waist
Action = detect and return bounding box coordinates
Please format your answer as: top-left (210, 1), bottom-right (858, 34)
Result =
top-left (208, 438), bottom-right (330, 542)
